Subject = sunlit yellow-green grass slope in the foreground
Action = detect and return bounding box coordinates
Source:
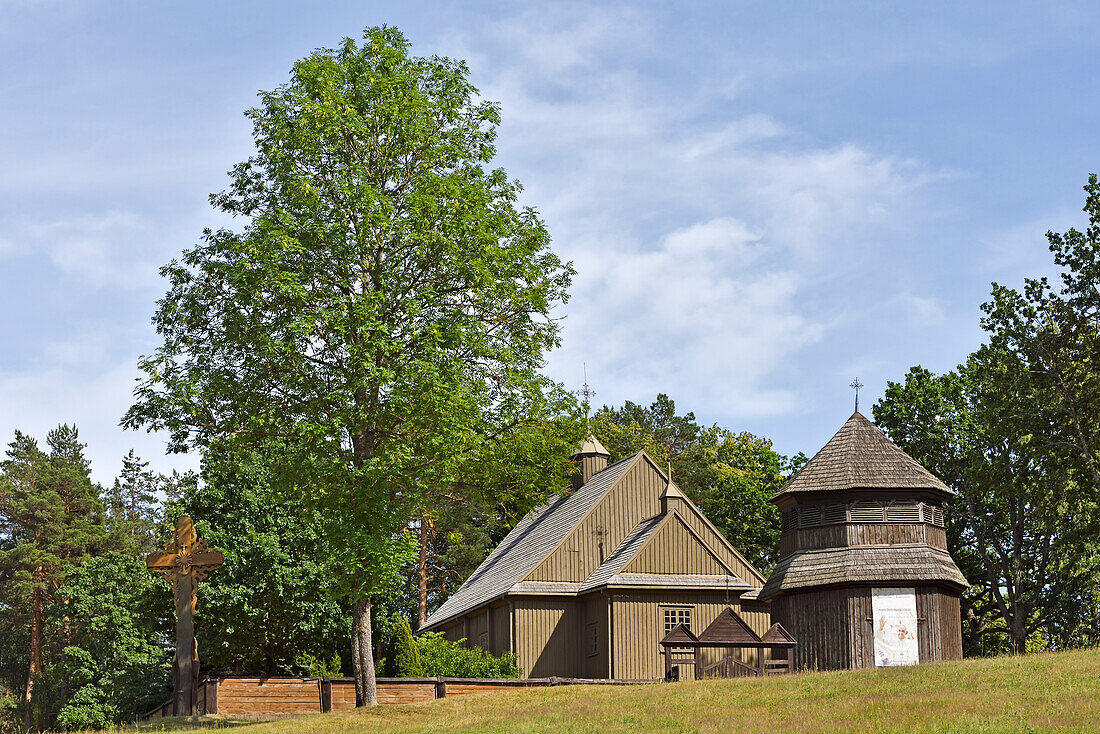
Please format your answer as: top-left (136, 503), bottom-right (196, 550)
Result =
top-left (120, 650), bottom-right (1100, 734)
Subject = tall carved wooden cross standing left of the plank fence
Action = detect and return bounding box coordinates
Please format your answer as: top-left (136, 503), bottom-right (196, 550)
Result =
top-left (145, 515), bottom-right (224, 716)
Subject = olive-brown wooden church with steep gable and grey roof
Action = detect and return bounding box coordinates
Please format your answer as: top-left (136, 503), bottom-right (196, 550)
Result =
top-left (425, 438), bottom-right (771, 679)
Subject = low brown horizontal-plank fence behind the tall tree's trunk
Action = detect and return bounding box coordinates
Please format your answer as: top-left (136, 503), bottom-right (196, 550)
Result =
top-left (142, 677), bottom-right (657, 720)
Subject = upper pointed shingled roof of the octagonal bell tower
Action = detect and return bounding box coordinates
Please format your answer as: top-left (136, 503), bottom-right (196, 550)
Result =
top-left (774, 412), bottom-right (954, 497)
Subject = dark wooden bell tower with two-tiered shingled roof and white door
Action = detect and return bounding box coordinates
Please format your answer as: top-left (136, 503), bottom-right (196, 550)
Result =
top-left (759, 409), bottom-right (967, 669)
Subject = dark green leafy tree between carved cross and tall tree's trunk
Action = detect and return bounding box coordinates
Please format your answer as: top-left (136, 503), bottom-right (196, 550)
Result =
top-left (162, 443), bottom-right (350, 676)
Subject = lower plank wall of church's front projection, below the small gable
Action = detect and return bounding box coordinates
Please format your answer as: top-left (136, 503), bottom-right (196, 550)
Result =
top-left (612, 591), bottom-right (771, 680)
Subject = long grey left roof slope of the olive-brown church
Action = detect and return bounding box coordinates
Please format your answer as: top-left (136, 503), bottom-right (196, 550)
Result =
top-left (425, 452), bottom-right (642, 628)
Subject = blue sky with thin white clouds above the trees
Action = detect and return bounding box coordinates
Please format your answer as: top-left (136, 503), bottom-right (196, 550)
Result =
top-left (0, 0), bottom-right (1100, 482)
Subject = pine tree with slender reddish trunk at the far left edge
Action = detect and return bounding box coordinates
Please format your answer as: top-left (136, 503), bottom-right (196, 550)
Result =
top-left (0, 425), bottom-right (107, 728)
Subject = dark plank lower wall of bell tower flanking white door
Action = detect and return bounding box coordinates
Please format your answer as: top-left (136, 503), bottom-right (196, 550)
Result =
top-left (772, 584), bottom-right (963, 670)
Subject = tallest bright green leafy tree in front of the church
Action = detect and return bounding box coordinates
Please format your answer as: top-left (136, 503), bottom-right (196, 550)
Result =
top-left (123, 28), bottom-right (573, 704)
